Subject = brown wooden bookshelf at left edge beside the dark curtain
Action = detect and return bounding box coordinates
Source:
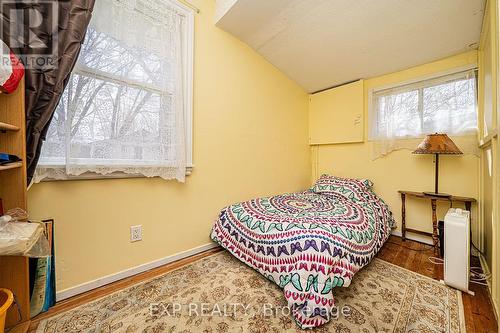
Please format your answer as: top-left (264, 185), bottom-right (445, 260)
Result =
top-left (0, 80), bottom-right (30, 332)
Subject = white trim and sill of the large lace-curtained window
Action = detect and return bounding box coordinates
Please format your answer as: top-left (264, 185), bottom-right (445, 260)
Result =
top-left (35, 0), bottom-right (195, 182)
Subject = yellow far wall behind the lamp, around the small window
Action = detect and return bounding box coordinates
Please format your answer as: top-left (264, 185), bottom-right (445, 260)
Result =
top-left (311, 51), bottom-right (479, 239)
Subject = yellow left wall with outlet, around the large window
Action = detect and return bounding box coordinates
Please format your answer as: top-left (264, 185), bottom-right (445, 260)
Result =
top-left (28, 0), bottom-right (310, 291)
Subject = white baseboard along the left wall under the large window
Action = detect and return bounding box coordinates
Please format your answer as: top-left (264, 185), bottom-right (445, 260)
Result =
top-left (56, 243), bottom-right (219, 302)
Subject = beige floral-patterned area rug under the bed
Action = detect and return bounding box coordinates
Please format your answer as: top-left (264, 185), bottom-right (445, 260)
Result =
top-left (37, 251), bottom-right (465, 333)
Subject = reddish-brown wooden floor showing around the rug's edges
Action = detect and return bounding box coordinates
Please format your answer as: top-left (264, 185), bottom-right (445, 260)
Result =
top-left (30, 236), bottom-right (497, 333)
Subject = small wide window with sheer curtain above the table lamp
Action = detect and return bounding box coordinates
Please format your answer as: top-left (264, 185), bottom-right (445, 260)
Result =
top-left (369, 70), bottom-right (477, 140)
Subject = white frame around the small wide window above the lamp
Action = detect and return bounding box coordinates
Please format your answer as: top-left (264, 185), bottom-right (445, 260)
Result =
top-left (367, 64), bottom-right (479, 142)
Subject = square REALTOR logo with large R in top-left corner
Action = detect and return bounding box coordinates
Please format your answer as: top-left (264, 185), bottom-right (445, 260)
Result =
top-left (0, 0), bottom-right (59, 69)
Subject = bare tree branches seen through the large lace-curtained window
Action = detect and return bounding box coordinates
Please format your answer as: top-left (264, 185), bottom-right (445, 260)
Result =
top-left (43, 29), bottom-right (175, 165)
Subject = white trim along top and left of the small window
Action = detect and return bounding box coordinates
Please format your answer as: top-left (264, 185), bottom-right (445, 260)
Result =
top-left (368, 64), bottom-right (478, 142)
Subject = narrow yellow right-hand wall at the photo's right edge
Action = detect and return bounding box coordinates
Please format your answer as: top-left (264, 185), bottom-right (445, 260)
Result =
top-left (478, 0), bottom-right (500, 315)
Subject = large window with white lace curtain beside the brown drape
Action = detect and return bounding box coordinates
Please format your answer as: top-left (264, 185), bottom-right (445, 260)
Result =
top-left (35, 0), bottom-right (193, 181)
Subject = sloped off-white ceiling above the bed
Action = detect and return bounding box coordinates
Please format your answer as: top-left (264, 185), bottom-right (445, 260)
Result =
top-left (216, 0), bottom-right (484, 92)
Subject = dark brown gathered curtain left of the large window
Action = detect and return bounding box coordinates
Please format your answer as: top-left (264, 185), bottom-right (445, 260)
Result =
top-left (1, 0), bottom-right (95, 184)
